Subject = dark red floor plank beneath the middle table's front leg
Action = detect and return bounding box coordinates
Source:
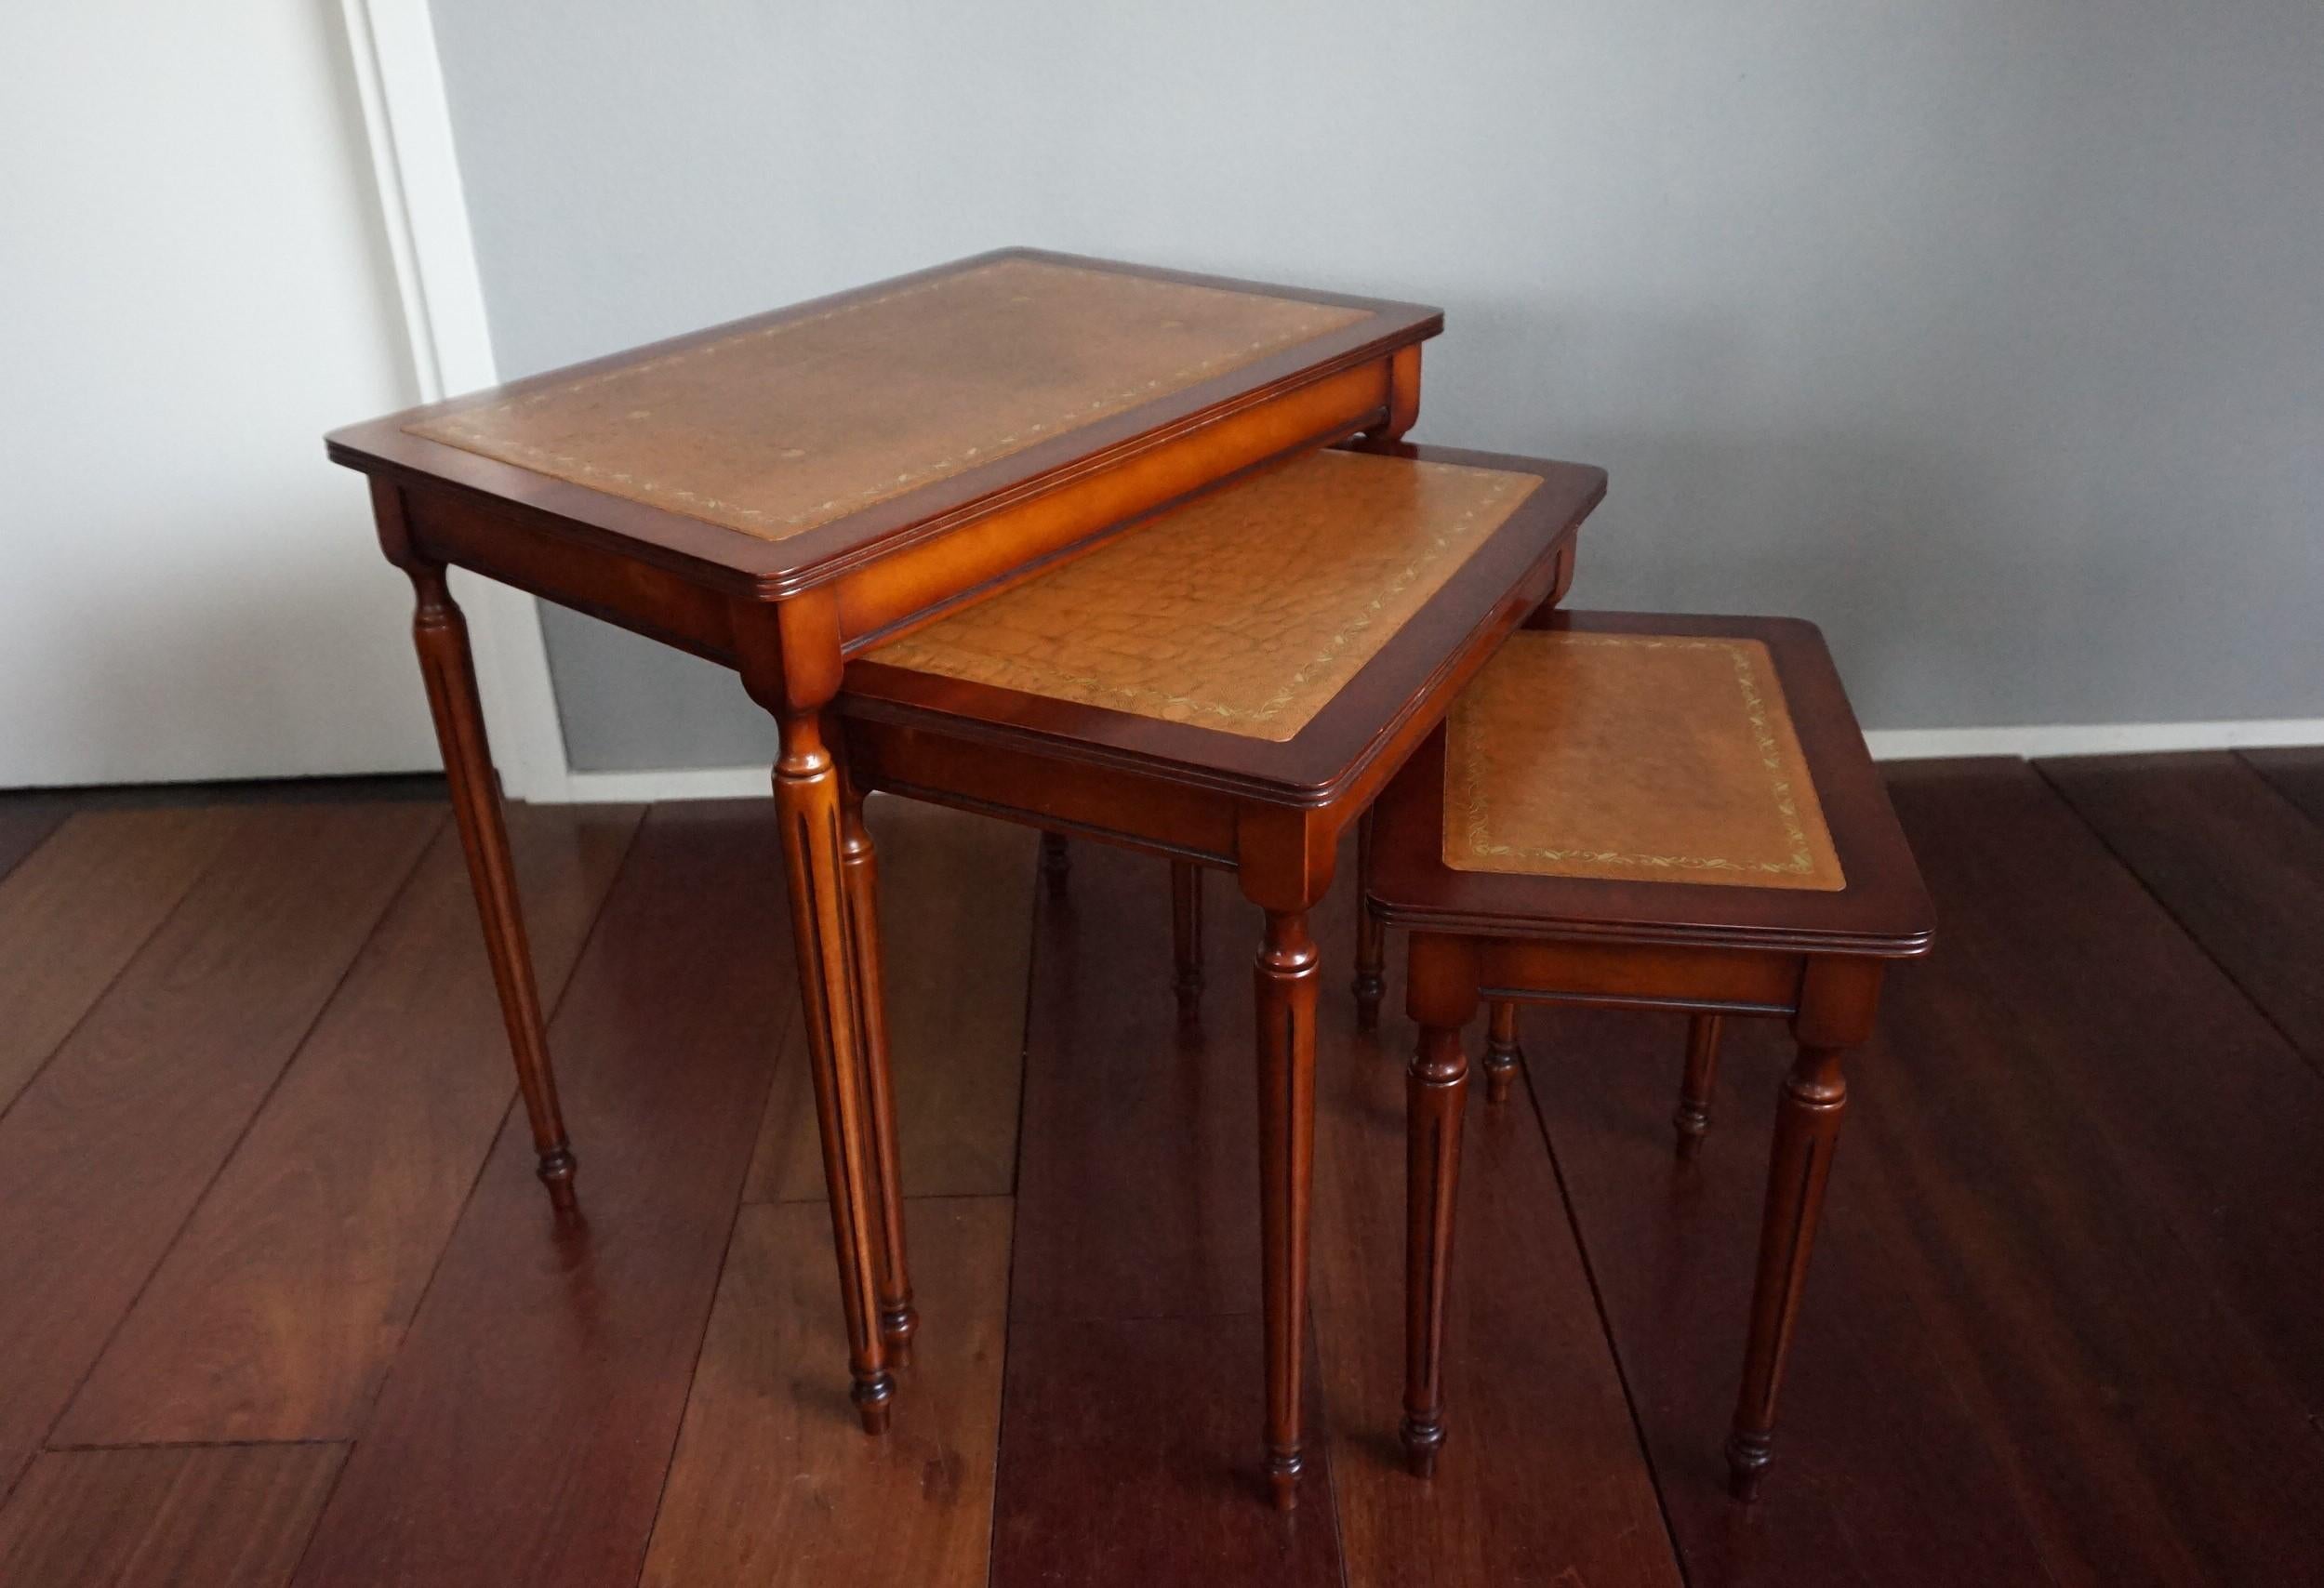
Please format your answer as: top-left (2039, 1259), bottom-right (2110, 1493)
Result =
top-left (992, 844), bottom-right (1341, 1588)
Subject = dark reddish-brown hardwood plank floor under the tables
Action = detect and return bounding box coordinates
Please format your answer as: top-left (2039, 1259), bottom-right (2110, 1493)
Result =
top-left (0, 751), bottom-right (2324, 1588)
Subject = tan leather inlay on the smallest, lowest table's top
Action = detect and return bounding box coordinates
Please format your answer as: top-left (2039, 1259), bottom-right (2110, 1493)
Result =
top-left (1443, 632), bottom-right (1848, 893)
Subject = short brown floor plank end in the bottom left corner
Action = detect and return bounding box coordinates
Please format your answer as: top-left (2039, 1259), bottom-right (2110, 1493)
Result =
top-left (0, 1444), bottom-right (346, 1588)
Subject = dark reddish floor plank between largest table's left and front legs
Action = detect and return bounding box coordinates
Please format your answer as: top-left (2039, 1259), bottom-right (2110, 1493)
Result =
top-left (298, 800), bottom-right (794, 1588)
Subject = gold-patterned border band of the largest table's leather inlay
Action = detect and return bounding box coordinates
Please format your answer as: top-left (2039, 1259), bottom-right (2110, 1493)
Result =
top-left (405, 258), bottom-right (1369, 539)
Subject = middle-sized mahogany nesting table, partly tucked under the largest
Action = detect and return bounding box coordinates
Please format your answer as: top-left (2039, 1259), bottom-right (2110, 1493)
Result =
top-left (837, 446), bottom-right (1606, 1506)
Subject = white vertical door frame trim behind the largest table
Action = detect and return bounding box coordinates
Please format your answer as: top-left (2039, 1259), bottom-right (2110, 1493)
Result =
top-left (339, 0), bottom-right (576, 802)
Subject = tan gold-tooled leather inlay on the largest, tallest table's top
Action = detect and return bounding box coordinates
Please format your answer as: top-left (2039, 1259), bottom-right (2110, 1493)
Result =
top-left (409, 258), bottom-right (1371, 539)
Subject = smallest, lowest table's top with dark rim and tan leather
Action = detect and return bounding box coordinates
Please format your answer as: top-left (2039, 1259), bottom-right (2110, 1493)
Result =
top-left (1371, 612), bottom-right (1933, 958)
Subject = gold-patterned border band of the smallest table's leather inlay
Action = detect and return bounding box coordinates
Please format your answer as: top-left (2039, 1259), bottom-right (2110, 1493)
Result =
top-left (1443, 632), bottom-right (1848, 893)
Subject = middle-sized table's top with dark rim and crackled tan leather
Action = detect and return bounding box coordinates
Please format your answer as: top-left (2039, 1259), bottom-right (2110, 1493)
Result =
top-left (839, 446), bottom-right (1606, 802)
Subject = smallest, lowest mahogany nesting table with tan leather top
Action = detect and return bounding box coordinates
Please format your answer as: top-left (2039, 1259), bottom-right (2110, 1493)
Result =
top-left (1369, 612), bottom-right (1933, 1500)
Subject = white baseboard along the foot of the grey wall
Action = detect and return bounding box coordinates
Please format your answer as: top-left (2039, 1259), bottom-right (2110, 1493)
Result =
top-left (546, 716), bottom-right (2324, 804)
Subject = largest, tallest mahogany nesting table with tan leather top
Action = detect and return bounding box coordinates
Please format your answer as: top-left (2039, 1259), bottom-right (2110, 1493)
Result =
top-left (327, 249), bottom-right (1443, 1432)
